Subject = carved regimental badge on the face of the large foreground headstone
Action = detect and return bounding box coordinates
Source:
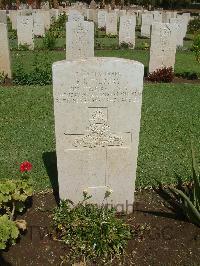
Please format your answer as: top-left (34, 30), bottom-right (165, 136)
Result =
top-left (73, 108), bottom-right (123, 148)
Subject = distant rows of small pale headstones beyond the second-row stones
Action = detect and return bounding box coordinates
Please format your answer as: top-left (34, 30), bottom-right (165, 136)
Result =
top-left (0, 9), bottom-right (190, 49)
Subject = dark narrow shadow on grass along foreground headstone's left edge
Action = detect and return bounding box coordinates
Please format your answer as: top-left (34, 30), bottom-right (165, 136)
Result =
top-left (42, 151), bottom-right (59, 204)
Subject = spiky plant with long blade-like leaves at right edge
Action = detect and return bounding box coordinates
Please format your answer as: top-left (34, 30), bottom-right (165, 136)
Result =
top-left (169, 148), bottom-right (200, 226)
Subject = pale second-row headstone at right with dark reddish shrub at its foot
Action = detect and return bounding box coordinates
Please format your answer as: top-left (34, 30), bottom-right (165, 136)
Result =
top-left (149, 22), bottom-right (176, 73)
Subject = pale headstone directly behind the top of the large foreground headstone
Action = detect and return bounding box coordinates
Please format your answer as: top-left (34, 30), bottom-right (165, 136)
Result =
top-left (66, 21), bottom-right (94, 59)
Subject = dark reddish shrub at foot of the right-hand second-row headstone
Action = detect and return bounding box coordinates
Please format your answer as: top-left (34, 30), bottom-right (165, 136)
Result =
top-left (147, 67), bottom-right (174, 82)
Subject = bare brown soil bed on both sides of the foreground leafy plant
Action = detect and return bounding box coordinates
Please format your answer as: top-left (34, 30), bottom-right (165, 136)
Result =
top-left (0, 190), bottom-right (200, 266)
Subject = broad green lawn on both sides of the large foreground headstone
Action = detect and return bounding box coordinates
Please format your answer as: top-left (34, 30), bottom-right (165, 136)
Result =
top-left (0, 84), bottom-right (200, 189)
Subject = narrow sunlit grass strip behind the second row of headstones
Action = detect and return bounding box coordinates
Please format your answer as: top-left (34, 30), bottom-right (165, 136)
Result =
top-left (11, 50), bottom-right (200, 77)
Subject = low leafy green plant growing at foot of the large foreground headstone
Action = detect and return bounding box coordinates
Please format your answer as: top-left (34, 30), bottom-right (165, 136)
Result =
top-left (53, 192), bottom-right (131, 262)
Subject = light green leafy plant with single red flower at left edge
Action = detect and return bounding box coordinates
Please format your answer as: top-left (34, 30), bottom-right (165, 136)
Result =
top-left (0, 162), bottom-right (33, 250)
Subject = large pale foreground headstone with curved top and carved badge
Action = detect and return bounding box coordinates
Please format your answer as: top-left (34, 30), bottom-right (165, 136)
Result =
top-left (53, 58), bottom-right (144, 212)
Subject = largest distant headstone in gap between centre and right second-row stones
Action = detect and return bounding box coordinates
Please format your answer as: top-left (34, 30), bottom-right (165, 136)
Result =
top-left (119, 16), bottom-right (136, 48)
